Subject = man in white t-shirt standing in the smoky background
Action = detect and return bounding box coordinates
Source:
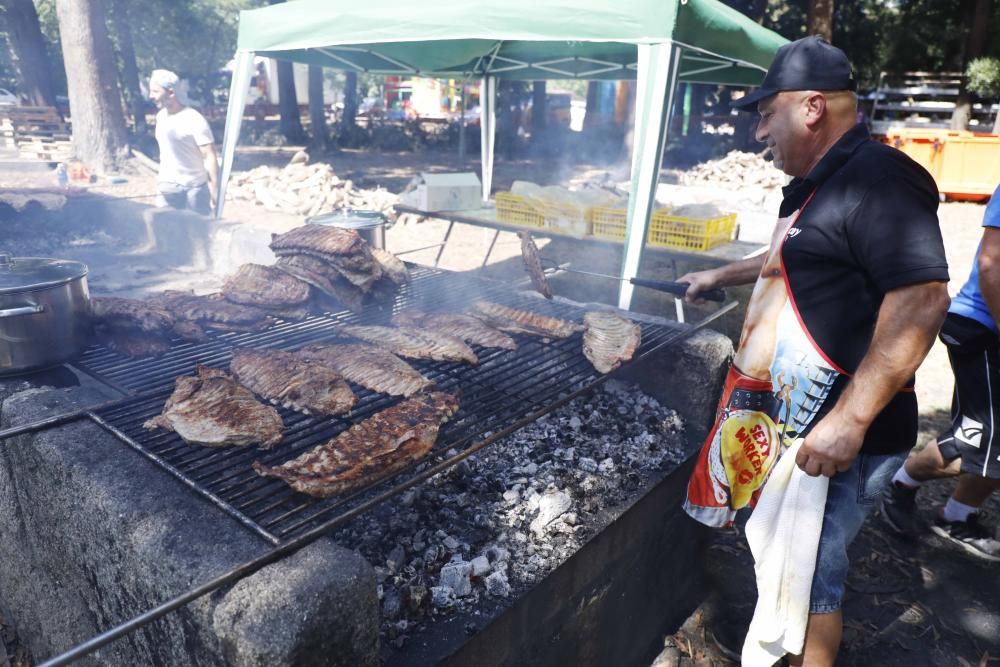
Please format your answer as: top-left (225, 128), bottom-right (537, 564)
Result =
top-left (149, 69), bottom-right (219, 215)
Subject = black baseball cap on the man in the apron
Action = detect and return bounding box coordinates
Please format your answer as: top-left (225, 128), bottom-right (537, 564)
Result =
top-left (732, 35), bottom-right (858, 111)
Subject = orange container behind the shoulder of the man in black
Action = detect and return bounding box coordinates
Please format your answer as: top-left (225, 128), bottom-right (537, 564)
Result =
top-left (885, 128), bottom-right (1000, 200)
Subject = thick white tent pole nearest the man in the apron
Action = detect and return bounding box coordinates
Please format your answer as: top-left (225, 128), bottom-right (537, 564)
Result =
top-left (618, 41), bottom-right (681, 310)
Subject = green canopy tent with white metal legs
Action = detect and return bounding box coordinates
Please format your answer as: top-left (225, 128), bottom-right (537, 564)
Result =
top-left (216, 0), bottom-right (786, 309)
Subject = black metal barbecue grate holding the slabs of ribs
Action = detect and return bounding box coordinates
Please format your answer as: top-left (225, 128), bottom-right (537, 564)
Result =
top-left (76, 265), bottom-right (689, 544)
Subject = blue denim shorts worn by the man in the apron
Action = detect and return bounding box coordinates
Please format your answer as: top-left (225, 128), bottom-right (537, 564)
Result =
top-left (809, 451), bottom-right (909, 614)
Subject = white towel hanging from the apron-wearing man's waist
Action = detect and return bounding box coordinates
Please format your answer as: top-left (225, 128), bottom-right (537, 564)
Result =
top-left (742, 439), bottom-right (830, 667)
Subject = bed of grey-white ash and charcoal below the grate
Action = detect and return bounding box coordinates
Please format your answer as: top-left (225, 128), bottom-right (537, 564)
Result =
top-left (337, 380), bottom-right (690, 648)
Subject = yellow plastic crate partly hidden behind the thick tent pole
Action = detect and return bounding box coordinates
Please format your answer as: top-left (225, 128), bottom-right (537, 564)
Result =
top-left (589, 206), bottom-right (736, 252)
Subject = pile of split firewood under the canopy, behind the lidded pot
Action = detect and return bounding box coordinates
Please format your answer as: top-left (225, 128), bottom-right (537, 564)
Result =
top-left (227, 161), bottom-right (398, 218)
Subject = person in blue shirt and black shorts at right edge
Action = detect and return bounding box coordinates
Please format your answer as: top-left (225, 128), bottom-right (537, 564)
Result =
top-left (882, 187), bottom-right (1000, 561)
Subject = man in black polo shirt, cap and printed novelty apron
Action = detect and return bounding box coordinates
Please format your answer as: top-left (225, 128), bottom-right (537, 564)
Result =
top-left (680, 37), bottom-right (949, 665)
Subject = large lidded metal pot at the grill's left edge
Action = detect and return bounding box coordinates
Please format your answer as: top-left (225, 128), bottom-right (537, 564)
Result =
top-left (0, 253), bottom-right (90, 375)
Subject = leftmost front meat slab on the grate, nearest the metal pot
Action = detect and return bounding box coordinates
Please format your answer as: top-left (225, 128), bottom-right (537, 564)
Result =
top-left (143, 366), bottom-right (284, 449)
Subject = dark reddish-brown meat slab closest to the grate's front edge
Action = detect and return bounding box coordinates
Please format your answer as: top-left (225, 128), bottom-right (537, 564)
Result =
top-left (253, 392), bottom-right (458, 498)
